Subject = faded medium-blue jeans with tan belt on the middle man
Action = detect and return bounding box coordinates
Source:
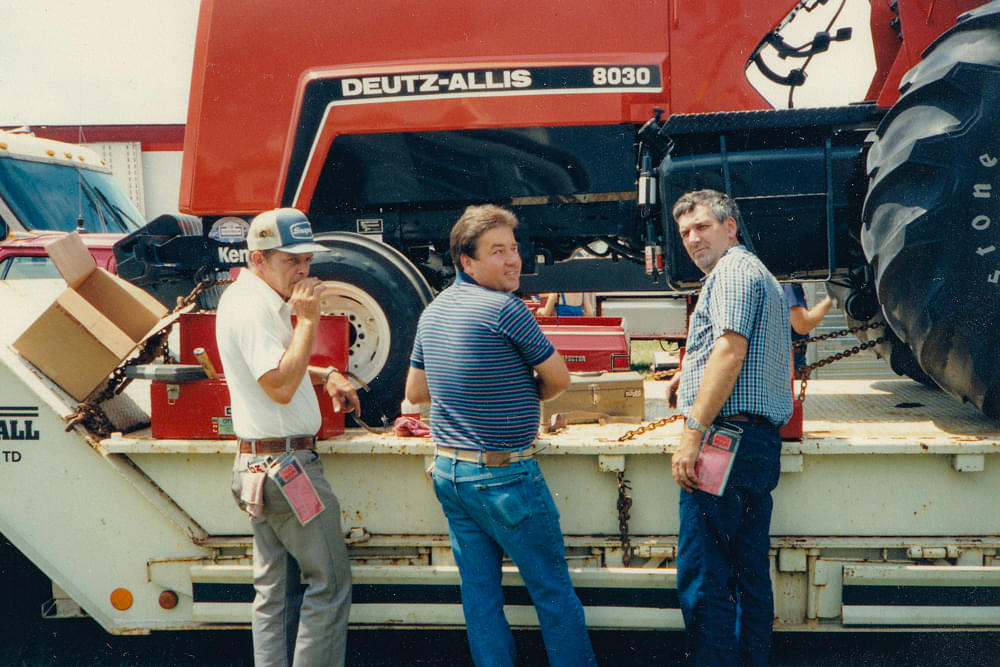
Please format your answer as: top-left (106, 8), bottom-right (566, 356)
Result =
top-left (434, 456), bottom-right (596, 667)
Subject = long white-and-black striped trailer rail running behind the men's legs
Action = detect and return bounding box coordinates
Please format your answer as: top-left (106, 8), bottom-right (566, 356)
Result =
top-left (191, 565), bottom-right (684, 630)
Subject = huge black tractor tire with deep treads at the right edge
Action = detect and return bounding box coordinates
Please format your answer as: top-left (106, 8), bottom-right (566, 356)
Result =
top-left (861, 2), bottom-right (1000, 419)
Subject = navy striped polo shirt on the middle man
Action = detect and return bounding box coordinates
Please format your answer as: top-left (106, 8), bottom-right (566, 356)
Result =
top-left (410, 273), bottom-right (555, 449)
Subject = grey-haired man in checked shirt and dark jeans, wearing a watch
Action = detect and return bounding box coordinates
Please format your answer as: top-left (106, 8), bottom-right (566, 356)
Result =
top-left (668, 190), bottom-right (792, 665)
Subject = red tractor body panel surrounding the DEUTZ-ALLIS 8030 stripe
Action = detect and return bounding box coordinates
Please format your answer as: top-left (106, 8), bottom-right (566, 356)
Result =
top-left (180, 0), bottom-right (812, 215)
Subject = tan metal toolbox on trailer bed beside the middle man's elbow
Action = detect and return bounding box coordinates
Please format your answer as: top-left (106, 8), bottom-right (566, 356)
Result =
top-left (542, 371), bottom-right (646, 423)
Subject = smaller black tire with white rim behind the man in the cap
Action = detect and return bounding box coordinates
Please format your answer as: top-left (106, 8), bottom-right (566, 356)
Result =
top-left (312, 232), bottom-right (434, 427)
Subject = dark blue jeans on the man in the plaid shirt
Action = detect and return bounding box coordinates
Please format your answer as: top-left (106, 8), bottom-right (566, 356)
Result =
top-left (677, 422), bottom-right (781, 665)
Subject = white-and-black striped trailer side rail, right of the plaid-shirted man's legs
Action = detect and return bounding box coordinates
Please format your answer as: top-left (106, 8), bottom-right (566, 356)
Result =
top-left (842, 563), bottom-right (1000, 626)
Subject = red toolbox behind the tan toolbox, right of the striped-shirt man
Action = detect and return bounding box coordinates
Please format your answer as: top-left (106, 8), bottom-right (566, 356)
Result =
top-left (538, 317), bottom-right (632, 372)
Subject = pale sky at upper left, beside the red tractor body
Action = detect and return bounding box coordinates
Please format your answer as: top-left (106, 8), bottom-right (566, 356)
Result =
top-left (0, 0), bottom-right (198, 125)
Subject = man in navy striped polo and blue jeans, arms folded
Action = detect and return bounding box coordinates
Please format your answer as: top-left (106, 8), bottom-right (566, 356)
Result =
top-left (406, 205), bottom-right (595, 665)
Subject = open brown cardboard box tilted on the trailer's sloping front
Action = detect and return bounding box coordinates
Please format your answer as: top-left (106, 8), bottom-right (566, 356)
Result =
top-left (13, 232), bottom-right (167, 401)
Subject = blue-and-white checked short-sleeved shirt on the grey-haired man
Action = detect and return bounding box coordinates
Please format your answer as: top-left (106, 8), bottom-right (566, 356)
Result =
top-left (677, 245), bottom-right (792, 425)
